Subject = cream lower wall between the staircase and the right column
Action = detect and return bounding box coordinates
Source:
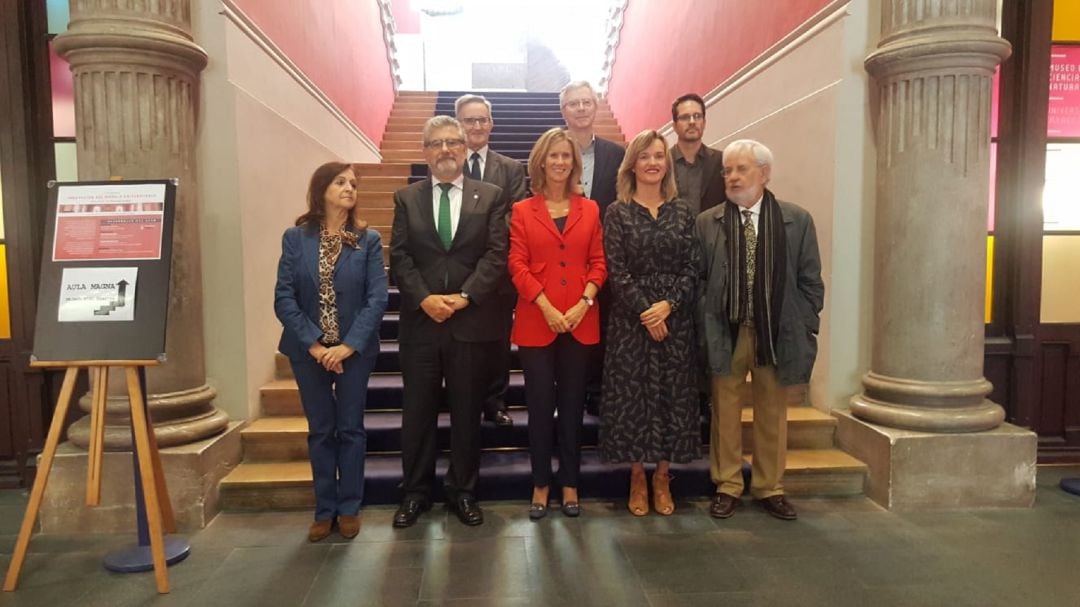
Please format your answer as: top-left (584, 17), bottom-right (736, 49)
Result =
top-left (664, 0), bottom-right (878, 410)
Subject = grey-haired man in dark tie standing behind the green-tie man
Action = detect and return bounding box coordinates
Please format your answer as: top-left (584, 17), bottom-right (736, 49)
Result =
top-left (454, 95), bottom-right (528, 427)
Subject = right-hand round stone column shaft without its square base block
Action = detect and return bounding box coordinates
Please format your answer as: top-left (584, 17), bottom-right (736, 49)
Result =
top-left (851, 0), bottom-right (1010, 432)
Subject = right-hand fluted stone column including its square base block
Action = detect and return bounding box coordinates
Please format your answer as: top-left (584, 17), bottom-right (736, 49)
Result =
top-left (835, 0), bottom-right (1037, 510)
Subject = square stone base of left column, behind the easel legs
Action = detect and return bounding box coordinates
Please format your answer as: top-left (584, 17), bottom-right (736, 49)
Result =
top-left (39, 421), bottom-right (243, 534)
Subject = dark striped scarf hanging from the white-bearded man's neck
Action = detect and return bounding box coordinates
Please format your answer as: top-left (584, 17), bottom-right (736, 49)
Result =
top-left (724, 189), bottom-right (787, 366)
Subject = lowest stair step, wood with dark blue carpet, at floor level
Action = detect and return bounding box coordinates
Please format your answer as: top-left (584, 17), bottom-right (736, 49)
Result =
top-left (220, 449), bottom-right (866, 511)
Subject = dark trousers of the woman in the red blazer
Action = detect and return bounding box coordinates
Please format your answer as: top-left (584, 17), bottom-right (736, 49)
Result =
top-left (518, 333), bottom-right (596, 487)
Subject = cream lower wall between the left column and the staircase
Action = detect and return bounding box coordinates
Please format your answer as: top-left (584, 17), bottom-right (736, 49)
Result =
top-left (192, 0), bottom-right (380, 419)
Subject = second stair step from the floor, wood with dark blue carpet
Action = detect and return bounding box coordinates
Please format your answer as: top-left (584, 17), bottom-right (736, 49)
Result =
top-left (241, 407), bottom-right (836, 461)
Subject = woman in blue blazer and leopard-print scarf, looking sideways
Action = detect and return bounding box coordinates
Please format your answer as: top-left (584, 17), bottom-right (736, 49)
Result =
top-left (274, 162), bottom-right (387, 542)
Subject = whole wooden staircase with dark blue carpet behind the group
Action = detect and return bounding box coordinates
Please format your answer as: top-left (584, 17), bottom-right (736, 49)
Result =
top-left (220, 92), bottom-right (866, 510)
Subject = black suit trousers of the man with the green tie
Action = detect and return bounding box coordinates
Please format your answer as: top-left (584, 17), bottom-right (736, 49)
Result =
top-left (401, 327), bottom-right (495, 501)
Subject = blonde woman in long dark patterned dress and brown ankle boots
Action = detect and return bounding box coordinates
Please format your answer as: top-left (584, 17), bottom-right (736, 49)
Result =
top-left (600, 131), bottom-right (701, 516)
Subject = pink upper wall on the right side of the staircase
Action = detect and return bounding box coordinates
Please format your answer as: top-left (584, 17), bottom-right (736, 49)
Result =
top-left (607, 0), bottom-right (833, 139)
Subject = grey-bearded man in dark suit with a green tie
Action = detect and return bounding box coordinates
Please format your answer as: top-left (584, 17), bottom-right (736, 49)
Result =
top-left (390, 116), bottom-right (509, 527)
